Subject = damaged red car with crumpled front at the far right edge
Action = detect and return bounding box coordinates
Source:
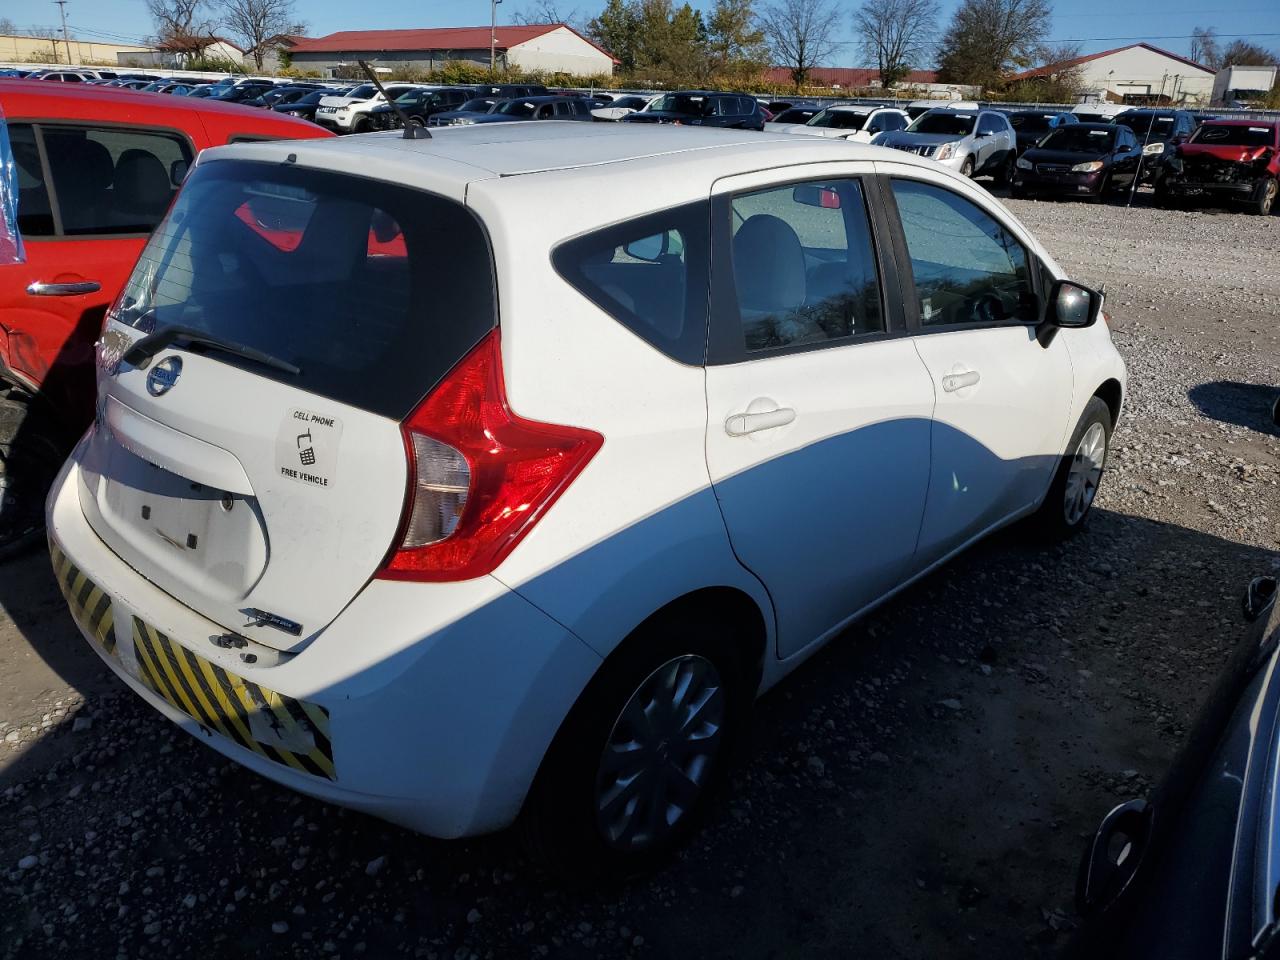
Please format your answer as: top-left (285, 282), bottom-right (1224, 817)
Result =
top-left (1156, 120), bottom-right (1280, 215)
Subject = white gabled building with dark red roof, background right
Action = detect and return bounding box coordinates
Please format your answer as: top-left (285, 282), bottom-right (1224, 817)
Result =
top-left (1014, 44), bottom-right (1213, 106)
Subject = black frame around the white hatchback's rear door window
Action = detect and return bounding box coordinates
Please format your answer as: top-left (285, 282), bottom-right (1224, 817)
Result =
top-left (707, 170), bottom-right (910, 366)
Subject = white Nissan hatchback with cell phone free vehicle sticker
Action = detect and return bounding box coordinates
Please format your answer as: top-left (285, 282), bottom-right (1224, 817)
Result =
top-left (47, 122), bottom-right (1125, 873)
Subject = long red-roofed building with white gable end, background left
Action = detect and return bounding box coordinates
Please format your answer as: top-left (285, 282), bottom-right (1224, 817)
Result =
top-left (288, 23), bottom-right (617, 77)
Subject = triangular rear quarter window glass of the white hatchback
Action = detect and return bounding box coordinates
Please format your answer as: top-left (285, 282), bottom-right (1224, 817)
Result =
top-left (552, 204), bottom-right (708, 364)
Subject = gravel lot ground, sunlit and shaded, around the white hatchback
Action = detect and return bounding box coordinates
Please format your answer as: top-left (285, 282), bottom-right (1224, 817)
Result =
top-left (0, 195), bottom-right (1280, 960)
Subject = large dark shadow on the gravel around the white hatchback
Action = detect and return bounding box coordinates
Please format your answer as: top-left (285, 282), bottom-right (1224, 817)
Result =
top-left (0, 509), bottom-right (1276, 959)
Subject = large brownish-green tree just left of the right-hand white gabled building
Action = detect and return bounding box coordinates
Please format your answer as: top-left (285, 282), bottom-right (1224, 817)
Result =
top-left (938, 0), bottom-right (1053, 87)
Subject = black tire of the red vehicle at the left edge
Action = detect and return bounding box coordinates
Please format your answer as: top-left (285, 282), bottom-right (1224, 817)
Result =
top-left (0, 393), bottom-right (67, 561)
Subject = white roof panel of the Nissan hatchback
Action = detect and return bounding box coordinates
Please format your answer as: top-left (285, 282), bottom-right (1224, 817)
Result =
top-left (202, 120), bottom-right (937, 198)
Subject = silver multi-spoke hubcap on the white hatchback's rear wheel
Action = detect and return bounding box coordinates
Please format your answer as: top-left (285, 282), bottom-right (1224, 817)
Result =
top-left (595, 655), bottom-right (726, 850)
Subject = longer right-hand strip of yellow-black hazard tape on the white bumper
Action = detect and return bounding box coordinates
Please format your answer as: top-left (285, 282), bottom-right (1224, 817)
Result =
top-left (133, 617), bottom-right (338, 780)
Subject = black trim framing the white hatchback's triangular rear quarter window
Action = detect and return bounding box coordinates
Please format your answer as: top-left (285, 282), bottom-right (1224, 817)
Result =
top-left (549, 200), bottom-right (710, 367)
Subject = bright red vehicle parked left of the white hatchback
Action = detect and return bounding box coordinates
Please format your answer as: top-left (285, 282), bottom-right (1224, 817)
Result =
top-left (0, 81), bottom-right (332, 557)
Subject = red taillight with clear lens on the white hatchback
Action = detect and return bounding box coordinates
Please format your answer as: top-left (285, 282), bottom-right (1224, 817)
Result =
top-left (378, 330), bottom-right (604, 581)
